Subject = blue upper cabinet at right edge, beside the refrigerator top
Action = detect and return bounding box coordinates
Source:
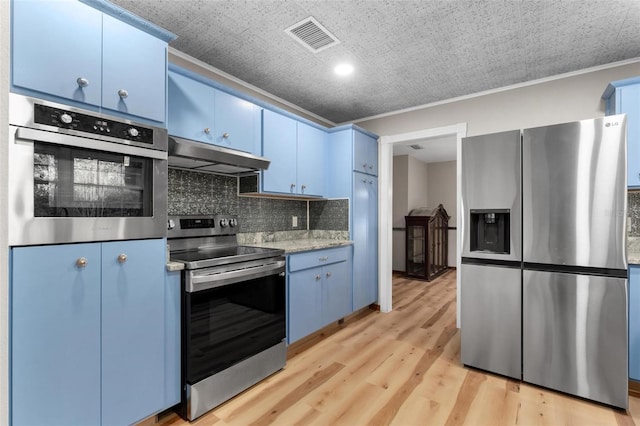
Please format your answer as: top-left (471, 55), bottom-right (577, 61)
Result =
top-left (602, 77), bottom-right (640, 188)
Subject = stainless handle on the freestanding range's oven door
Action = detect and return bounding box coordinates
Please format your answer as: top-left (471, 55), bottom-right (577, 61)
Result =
top-left (185, 260), bottom-right (286, 293)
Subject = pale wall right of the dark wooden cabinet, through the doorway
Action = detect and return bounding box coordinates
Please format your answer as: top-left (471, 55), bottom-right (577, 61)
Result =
top-left (427, 161), bottom-right (458, 267)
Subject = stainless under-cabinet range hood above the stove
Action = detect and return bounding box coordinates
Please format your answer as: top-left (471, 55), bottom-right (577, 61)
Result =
top-left (168, 136), bottom-right (270, 174)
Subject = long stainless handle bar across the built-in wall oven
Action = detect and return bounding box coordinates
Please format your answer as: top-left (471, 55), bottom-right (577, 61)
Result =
top-left (16, 127), bottom-right (167, 160)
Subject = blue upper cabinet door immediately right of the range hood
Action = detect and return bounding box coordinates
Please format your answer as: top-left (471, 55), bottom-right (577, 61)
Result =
top-left (262, 110), bottom-right (298, 194)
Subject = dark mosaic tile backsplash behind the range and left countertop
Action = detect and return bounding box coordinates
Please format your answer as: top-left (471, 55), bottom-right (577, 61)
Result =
top-left (168, 168), bottom-right (349, 233)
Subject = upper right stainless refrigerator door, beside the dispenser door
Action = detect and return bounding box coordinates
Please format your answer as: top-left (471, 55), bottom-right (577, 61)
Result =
top-left (522, 115), bottom-right (627, 269)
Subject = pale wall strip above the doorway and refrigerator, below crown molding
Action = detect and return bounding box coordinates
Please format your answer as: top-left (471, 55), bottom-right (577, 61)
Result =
top-left (357, 61), bottom-right (640, 136)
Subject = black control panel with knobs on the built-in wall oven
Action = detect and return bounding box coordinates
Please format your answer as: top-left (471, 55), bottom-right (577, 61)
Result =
top-left (33, 104), bottom-right (153, 145)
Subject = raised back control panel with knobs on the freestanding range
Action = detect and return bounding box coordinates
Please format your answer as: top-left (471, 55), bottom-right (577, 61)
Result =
top-left (167, 215), bottom-right (238, 238)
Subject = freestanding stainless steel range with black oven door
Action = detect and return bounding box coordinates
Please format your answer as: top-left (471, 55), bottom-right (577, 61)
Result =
top-left (167, 215), bottom-right (286, 420)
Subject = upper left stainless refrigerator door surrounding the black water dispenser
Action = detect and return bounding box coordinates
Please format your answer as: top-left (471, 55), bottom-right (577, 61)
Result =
top-left (461, 130), bottom-right (522, 261)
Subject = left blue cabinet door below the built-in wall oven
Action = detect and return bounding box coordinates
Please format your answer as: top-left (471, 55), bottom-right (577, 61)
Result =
top-left (10, 243), bottom-right (100, 425)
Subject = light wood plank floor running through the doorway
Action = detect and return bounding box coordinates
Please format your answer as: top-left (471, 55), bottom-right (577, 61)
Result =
top-left (156, 271), bottom-right (640, 426)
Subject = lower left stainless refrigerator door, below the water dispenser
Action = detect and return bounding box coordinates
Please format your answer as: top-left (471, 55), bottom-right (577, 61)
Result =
top-left (460, 264), bottom-right (522, 380)
